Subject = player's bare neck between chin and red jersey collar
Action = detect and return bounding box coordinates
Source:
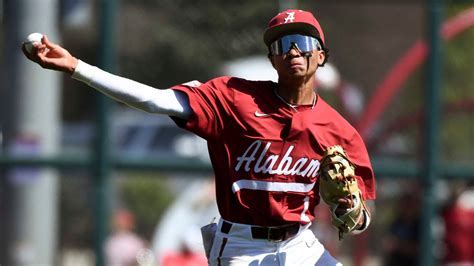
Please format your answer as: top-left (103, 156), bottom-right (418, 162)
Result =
top-left (276, 80), bottom-right (316, 105)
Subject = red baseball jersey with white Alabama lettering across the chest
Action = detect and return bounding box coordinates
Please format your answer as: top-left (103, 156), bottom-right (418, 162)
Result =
top-left (173, 77), bottom-right (375, 226)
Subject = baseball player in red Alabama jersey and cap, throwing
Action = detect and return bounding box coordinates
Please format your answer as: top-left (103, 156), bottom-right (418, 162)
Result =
top-left (23, 10), bottom-right (375, 265)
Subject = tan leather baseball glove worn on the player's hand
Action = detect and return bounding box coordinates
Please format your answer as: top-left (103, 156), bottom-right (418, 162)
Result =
top-left (319, 145), bottom-right (368, 239)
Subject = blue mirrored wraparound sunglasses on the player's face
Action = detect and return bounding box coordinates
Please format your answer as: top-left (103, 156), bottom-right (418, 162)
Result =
top-left (270, 34), bottom-right (322, 55)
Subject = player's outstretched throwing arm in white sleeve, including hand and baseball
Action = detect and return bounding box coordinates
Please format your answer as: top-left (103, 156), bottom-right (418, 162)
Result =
top-left (22, 33), bottom-right (191, 119)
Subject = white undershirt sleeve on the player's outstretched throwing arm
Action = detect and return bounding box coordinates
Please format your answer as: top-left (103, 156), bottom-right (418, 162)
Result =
top-left (72, 60), bottom-right (192, 119)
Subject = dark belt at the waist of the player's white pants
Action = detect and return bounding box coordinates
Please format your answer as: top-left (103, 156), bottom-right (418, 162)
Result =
top-left (221, 221), bottom-right (300, 241)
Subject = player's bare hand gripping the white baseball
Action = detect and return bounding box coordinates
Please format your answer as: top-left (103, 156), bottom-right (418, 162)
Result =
top-left (21, 35), bottom-right (78, 74)
